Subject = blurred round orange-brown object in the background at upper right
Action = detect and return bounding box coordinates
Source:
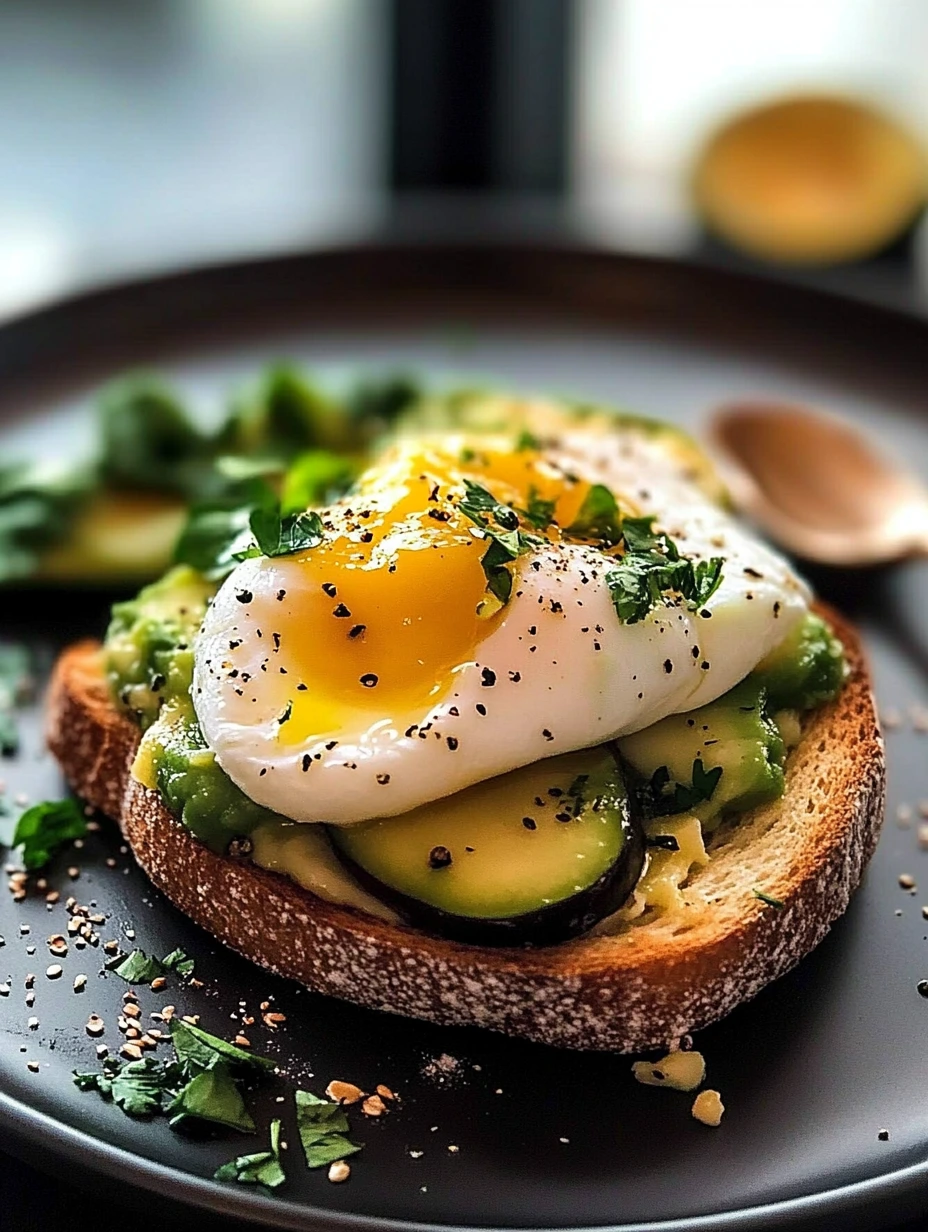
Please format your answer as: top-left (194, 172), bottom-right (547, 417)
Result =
top-left (693, 95), bottom-right (928, 265)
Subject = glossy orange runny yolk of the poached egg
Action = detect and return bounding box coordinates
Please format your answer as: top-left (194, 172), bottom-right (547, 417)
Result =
top-left (275, 442), bottom-right (589, 744)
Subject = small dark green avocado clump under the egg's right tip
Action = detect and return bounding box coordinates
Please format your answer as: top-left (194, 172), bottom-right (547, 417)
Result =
top-left (752, 612), bottom-right (848, 711)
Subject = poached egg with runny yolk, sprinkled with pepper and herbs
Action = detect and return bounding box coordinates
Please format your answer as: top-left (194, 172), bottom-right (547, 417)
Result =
top-left (192, 408), bottom-right (810, 824)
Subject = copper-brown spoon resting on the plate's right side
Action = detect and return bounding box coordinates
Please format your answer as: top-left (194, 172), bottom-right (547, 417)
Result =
top-left (709, 402), bottom-right (928, 565)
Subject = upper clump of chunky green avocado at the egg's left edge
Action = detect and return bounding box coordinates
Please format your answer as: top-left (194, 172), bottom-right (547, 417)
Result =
top-left (104, 565), bottom-right (216, 728)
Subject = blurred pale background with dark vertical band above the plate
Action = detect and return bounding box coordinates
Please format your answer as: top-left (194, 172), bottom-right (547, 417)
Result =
top-left (0, 0), bottom-right (928, 317)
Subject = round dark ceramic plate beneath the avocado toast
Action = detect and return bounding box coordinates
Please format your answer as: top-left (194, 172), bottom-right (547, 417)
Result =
top-left (0, 248), bottom-right (928, 1232)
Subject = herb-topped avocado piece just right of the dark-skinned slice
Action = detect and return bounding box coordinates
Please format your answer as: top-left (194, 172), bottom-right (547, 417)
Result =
top-left (617, 678), bottom-right (785, 824)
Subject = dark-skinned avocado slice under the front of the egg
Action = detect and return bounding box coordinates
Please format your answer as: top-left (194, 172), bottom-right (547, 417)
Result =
top-left (329, 748), bottom-right (645, 945)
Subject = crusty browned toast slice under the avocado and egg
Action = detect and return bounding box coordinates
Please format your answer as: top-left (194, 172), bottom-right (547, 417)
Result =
top-left (48, 607), bottom-right (885, 1052)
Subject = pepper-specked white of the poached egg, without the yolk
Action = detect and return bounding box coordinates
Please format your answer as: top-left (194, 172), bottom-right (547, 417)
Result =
top-left (192, 431), bottom-right (808, 824)
